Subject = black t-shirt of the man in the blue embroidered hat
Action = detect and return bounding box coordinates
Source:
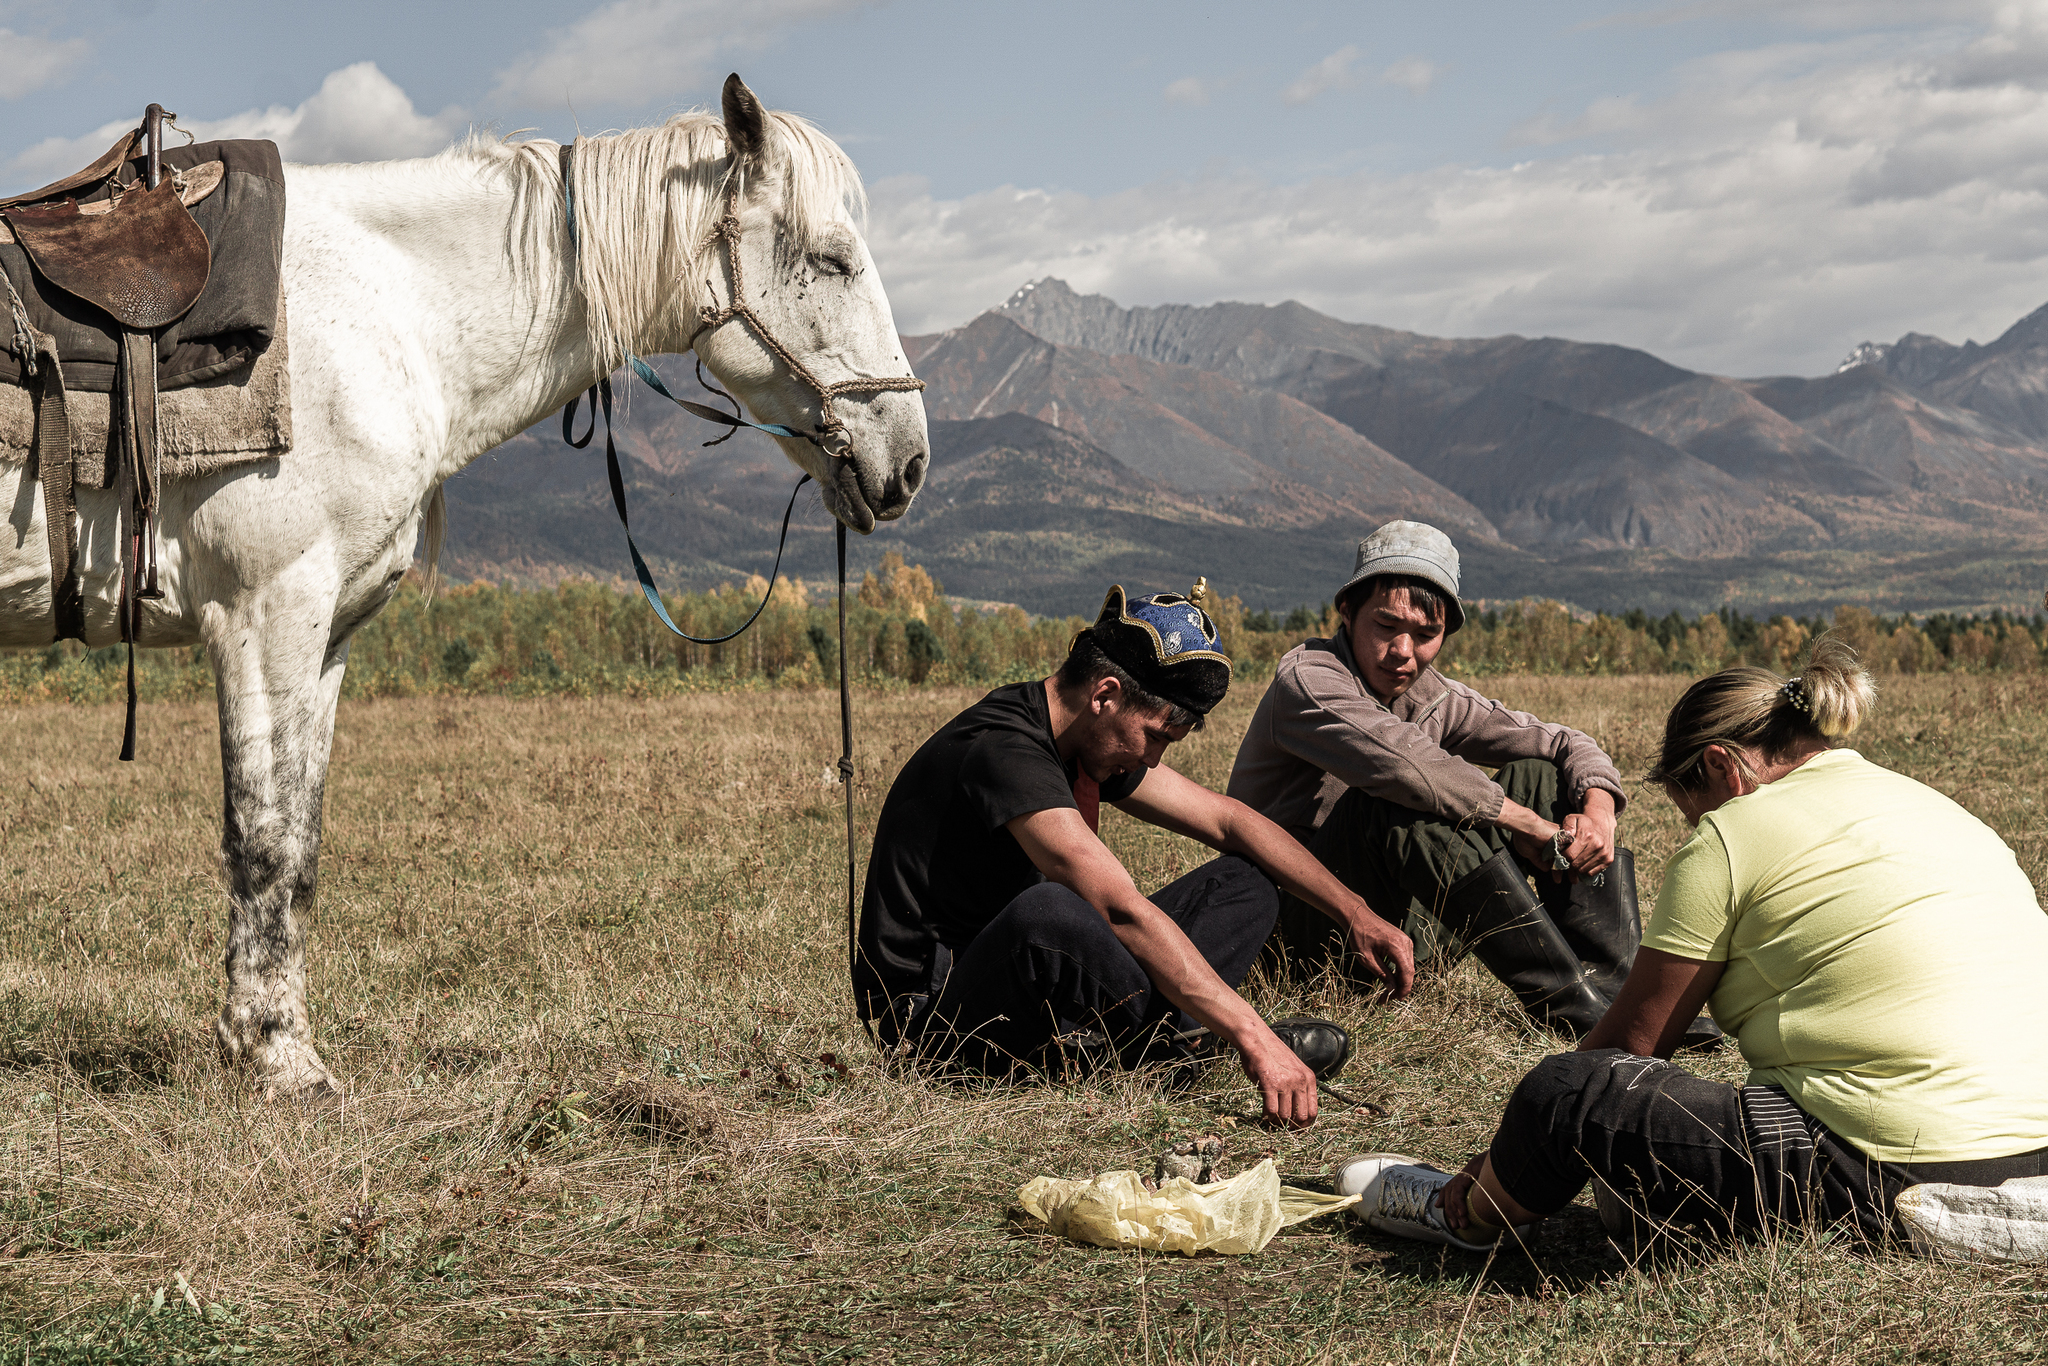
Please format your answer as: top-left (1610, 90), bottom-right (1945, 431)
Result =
top-left (854, 682), bottom-right (1145, 1020)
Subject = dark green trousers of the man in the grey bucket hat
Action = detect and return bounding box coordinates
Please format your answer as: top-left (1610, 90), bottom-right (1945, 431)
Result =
top-left (1268, 760), bottom-right (1577, 985)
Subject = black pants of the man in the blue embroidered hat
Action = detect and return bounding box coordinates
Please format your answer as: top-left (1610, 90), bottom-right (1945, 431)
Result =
top-left (918, 854), bottom-right (1280, 1075)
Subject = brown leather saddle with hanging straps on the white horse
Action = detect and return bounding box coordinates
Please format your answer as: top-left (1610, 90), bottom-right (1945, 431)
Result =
top-left (0, 104), bottom-right (213, 758)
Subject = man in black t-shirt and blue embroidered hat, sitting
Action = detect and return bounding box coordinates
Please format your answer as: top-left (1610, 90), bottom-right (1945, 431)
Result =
top-left (854, 584), bottom-right (1415, 1122)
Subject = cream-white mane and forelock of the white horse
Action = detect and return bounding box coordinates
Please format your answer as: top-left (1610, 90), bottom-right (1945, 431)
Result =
top-left (449, 111), bottom-right (866, 373)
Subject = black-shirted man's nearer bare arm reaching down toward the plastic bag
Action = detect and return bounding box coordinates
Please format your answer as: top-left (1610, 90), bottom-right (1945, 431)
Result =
top-left (1008, 806), bottom-right (1315, 1124)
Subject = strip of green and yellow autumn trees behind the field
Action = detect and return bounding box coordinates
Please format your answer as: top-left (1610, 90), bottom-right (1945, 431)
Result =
top-left (0, 553), bottom-right (2048, 702)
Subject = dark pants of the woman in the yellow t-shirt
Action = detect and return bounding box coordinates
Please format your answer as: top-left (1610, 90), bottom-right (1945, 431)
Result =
top-left (1489, 1049), bottom-right (2048, 1239)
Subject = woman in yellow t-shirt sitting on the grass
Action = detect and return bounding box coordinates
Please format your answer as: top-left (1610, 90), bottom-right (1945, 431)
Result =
top-left (1341, 637), bottom-right (2048, 1249)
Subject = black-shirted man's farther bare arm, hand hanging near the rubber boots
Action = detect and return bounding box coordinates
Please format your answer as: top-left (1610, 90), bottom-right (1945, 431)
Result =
top-left (1116, 764), bottom-right (1415, 995)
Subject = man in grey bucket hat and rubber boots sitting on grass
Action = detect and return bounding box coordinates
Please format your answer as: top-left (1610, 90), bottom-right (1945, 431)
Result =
top-left (1229, 522), bottom-right (1718, 1042)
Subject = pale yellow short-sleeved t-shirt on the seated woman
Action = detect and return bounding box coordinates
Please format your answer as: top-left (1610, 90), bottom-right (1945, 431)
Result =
top-left (1642, 750), bottom-right (2048, 1161)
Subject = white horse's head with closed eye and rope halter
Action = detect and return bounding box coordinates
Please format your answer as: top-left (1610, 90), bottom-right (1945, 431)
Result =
top-left (688, 76), bottom-right (930, 532)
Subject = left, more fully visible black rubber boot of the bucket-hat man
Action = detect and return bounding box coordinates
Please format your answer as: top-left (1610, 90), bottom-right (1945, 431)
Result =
top-left (1438, 850), bottom-right (1608, 1038)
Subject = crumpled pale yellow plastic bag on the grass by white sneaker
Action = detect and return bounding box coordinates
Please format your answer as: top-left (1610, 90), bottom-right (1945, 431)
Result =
top-left (1018, 1157), bottom-right (1358, 1257)
